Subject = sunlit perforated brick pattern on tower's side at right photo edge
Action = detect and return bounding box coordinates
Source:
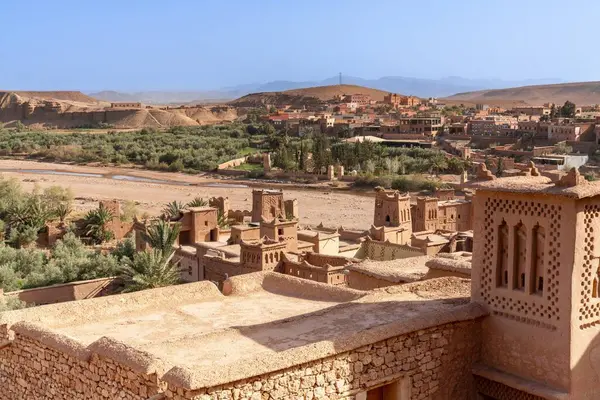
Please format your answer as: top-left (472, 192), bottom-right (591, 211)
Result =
top-left (579, 205), bottom-right (600, 329)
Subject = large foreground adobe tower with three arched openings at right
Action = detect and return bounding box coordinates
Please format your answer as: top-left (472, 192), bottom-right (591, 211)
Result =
top-left (472, 170), bottom-right (600, 400)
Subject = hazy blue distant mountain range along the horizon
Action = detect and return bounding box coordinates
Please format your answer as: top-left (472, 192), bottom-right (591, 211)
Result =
top-left (87, 76), bottom-right (562, 104)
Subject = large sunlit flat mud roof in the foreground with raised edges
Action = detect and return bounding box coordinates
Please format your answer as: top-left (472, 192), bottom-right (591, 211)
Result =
top-left (0, 272), bottom-right (485, 389)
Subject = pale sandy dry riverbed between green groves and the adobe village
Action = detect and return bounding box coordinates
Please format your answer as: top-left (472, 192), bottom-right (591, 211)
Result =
top-left (0, 160), bottom-right (374, 229)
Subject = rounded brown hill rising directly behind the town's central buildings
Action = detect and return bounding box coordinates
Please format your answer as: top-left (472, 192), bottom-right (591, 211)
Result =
top-left (229, 85), bottom-right (388, 107)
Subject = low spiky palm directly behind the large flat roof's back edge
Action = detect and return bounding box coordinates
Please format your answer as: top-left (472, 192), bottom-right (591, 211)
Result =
top-left (120, 249), bottom-right (180, 292)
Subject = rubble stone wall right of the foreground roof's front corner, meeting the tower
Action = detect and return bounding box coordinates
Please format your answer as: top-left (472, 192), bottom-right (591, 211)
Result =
top-left (166, 321), bottom-right (479, 400)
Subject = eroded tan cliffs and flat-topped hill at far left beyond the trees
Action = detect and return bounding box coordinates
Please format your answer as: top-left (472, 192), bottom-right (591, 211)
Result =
top-left (0, 92), bottom-right (238, 129)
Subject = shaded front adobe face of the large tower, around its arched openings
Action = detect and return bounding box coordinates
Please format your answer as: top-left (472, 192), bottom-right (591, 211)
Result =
top-left (471, 190), bottom-right (583, 391)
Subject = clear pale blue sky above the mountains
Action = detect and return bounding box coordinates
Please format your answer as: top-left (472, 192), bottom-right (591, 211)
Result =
top-left (0, 0), bottom-right (600, 90)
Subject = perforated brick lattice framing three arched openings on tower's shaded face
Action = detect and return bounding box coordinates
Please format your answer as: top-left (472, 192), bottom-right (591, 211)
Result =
top-left (481, 198), bottom-right (562, 330)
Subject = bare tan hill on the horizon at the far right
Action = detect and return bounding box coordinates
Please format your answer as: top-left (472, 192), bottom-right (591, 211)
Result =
top-left (448, 82), bottom-right (600, 105)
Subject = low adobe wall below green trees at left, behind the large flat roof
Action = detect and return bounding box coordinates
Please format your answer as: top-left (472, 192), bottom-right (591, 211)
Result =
top-left (4, 278), bottom-right (120, 305)
